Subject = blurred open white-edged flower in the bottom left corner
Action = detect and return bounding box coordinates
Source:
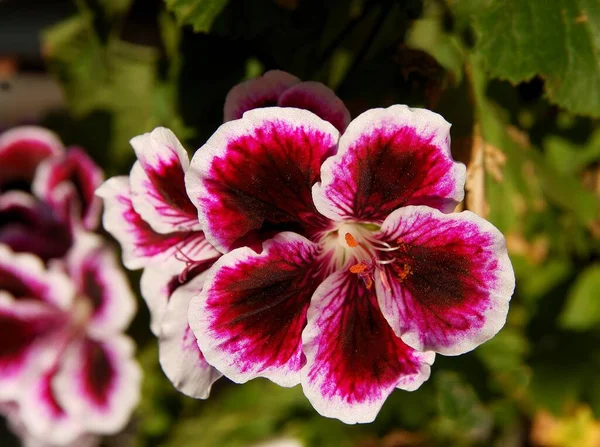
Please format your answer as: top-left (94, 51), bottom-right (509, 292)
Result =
top-left (0, 238), bottom-right (141, 444)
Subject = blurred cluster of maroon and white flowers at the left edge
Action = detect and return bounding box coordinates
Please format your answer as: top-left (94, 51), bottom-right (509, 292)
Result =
top-left (0, 126), bottom-right (141, 445)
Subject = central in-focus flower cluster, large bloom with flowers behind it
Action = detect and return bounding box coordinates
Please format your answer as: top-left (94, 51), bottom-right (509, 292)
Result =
top-left (99, 72), bottom-right (514, 423)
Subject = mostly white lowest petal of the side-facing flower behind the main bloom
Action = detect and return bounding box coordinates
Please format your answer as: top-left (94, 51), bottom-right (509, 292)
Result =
top-left (159, 274), bottom-right (222, 399)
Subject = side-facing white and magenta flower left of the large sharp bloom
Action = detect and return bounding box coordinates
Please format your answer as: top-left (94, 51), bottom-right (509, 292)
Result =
top-left (97, 128), bottom-right (221, 399)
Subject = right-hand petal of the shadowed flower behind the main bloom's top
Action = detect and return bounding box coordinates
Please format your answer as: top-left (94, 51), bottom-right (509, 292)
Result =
top-left (277, 81), bottom-right (350, 133)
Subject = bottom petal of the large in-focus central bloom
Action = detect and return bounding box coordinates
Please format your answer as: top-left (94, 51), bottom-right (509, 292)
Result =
top-left (302, 270), bottom-right (435, 424)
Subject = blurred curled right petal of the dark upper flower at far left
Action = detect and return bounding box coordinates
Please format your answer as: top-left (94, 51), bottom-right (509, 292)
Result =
top-left (32, 148), bottom-right (104, 230)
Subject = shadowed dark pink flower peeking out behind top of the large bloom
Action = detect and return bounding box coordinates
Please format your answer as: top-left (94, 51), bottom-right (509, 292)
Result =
top-left (223, 70), bottom-right (350, 132)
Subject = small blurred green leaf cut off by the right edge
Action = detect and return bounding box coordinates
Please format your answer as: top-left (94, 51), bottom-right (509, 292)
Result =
top-left (559, 263), bottom-right (600, 330)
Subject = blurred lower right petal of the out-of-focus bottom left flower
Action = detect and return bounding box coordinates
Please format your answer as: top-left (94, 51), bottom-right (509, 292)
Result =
top-left (53, 335), bottom-right (142, 434)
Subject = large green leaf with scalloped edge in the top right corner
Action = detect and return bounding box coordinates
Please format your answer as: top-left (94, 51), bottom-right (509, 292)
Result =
top-left (466, 0), bottom-right (600, 117)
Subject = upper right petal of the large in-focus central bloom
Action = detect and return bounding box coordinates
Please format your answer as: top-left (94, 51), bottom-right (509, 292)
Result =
top-left (313, 105), bottom-right (466, 222)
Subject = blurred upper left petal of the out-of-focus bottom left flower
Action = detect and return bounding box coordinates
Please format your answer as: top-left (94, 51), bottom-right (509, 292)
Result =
top-left (0, 244), bottom-right (74, 309)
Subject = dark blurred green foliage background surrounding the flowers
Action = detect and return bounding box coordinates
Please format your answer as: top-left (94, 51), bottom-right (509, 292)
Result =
top-left (0, 0), bottom-right (600, 447)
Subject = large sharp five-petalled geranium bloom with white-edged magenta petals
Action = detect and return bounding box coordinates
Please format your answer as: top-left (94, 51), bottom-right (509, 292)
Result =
top-left (186, 106), bottom-right (514, 423)
